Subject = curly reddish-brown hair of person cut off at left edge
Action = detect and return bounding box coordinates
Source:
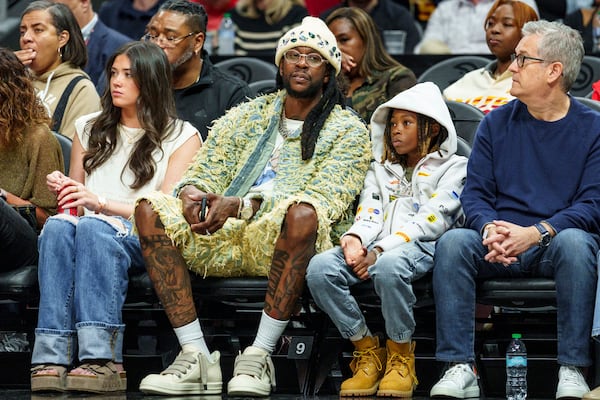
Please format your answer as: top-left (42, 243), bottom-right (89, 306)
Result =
top-left (0, 47), bottom-right (50, 148)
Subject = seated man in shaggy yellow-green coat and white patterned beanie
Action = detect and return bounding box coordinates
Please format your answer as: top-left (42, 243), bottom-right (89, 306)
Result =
top-left (135, 17), bottom-right (371, 397)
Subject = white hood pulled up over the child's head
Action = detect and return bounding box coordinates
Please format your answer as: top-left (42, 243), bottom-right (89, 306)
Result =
top-left (371, 82), bottom-right (457, 161)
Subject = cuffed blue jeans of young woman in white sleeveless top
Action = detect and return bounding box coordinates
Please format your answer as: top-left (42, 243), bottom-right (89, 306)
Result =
top-left (32, 216), bottom-right (144, 365)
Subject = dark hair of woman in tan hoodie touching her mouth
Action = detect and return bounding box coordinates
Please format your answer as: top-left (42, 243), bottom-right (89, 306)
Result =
top-left (21, 0), bottom-right (87, 68)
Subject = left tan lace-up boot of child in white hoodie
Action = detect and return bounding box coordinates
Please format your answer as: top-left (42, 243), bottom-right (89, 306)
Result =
top-left (340, 336), bottom-right (385, 396)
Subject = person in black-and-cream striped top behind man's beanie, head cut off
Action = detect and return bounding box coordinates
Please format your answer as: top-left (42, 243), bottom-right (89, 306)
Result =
top-left (231, 0), bottom-right (308, 58)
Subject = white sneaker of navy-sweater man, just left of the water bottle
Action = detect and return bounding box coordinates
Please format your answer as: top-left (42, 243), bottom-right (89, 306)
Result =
top-left (429, 364), bottom-right (479, 399)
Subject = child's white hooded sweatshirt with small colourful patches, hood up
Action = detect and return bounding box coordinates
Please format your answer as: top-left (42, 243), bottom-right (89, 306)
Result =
top-left (346, 82), bottom-right (467, 251)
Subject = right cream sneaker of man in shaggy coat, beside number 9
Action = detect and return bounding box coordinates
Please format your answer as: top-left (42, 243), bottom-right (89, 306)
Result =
top-left (227, 346), bottom-right (275, 396)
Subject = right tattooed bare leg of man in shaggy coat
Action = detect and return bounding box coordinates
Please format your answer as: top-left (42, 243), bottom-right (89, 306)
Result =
top-left (264, 203), bottom-right (317, 321)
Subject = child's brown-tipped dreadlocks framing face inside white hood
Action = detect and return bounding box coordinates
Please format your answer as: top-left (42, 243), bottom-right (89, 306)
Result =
top-left (381, 109), bottom-right (448, 167)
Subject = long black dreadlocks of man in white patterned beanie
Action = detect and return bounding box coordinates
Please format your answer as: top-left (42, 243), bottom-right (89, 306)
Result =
top-left (277, 64), bottom-right (346, 161)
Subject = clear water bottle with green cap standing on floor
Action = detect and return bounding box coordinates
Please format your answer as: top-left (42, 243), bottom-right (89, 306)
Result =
top-left (506, 333), bottom-right (527, 400)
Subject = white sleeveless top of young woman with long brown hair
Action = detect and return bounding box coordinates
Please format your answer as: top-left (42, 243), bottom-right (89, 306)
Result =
top-left (75, 112), bottom-right (202, 212)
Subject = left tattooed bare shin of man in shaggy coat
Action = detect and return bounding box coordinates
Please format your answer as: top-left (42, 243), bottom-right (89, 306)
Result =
top-left (135, 201), bottom-right (197, 328)
